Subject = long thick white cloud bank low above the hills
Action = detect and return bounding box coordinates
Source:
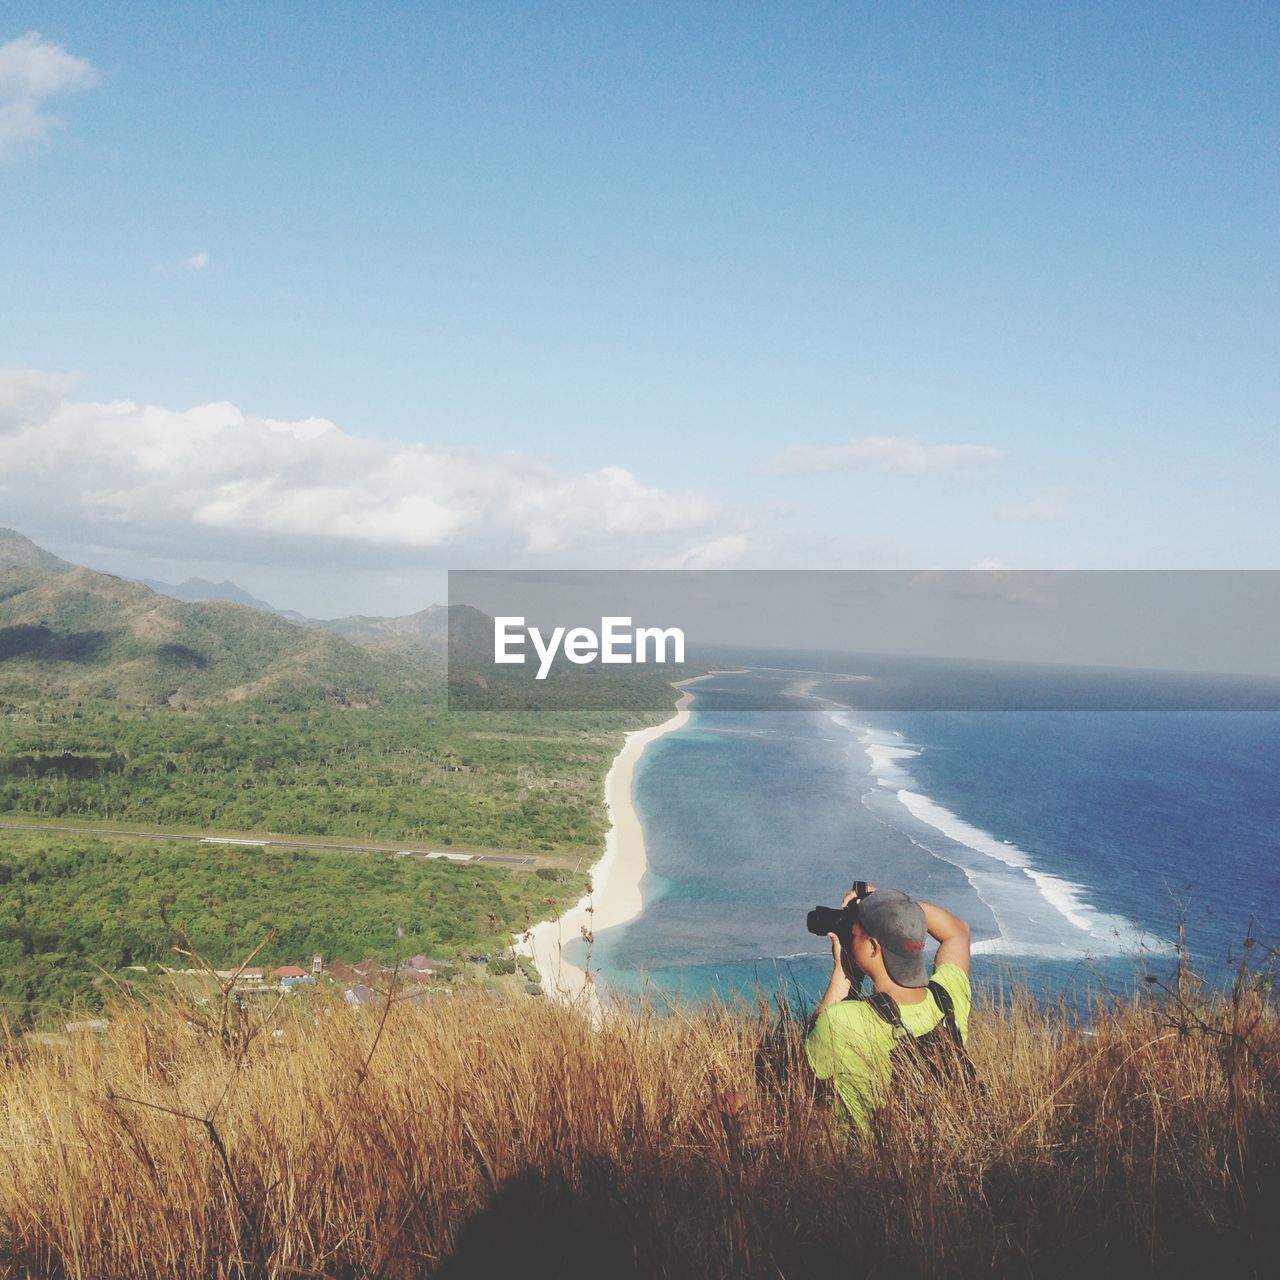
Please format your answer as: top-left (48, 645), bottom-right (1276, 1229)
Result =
top-left (0, 370), bottom-right (728, 564)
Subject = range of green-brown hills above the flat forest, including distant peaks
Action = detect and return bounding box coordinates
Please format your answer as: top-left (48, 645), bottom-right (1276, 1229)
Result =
top-left (0, 530), bottom-right (670, 714)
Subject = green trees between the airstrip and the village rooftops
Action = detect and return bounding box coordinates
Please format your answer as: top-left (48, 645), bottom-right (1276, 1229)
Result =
top-left (0, 833), bottom-right (582, 1021)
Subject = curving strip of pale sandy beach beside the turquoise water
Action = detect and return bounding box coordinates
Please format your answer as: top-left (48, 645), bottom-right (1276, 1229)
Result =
top-left (515, 672), bottom-right (714, 1014)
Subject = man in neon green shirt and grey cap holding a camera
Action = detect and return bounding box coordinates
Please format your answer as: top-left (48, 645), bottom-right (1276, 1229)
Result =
top-left (805, 884), bottom-right (973, 1130)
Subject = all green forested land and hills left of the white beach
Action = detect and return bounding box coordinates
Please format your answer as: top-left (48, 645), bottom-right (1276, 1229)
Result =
top-left (0, 535), bottom-right (684, 1023)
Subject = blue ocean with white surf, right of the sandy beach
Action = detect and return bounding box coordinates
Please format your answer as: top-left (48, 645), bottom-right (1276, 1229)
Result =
top-left (572, 668), bottom-right (1280, 1007)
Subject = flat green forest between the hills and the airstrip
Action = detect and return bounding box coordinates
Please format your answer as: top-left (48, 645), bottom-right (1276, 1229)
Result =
top-left (0, 707), bottom-right (660, 852)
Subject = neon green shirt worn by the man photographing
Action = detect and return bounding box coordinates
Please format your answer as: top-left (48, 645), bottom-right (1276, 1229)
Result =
top-left (805, 964), bottom-right (973, 1129)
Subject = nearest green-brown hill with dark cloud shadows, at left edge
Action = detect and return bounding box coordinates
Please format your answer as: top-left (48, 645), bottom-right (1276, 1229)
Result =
top-left (0, 568), bottom-right (439, 708)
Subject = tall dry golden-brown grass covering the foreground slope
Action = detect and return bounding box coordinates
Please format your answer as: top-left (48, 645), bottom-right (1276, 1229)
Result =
top-left (0, 967), bottom-right (1280, 1277)
